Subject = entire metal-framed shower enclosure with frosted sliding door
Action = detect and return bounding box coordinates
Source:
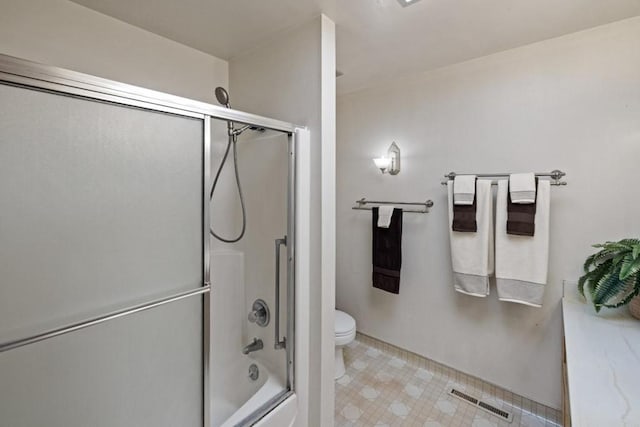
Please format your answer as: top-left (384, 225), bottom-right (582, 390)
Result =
top-left (0, 55), bottom-right (297, 427)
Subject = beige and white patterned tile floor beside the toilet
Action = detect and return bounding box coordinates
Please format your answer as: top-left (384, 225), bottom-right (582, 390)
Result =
top-left (335, 336), bottom-right (560, 427)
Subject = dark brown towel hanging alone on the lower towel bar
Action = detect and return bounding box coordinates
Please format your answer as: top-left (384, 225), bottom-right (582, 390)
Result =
top-left (371, 208), bottom-right (402, 294)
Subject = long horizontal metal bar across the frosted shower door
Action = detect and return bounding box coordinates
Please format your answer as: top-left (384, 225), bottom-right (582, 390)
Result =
top-left (0, 285), bottom-right (211, 353)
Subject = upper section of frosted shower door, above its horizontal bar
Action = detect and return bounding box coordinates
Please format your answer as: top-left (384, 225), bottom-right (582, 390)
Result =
top-left (0, 85), bottom-right (203, 338)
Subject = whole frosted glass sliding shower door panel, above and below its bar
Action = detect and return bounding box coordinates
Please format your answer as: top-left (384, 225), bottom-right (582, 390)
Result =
top-left (0, 84), bottom-right (205, 427)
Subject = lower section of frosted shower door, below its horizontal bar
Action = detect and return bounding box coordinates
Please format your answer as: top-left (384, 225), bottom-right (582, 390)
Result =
top-left (0, 297), bottom-right (202, 427)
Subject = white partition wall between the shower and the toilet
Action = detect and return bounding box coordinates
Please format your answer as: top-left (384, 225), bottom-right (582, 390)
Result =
top-left (229, 16), bottom-right (335, 426)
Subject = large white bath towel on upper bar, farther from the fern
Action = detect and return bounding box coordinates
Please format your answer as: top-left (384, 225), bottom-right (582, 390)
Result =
top-left (447, 180), bottom-right (494, 297)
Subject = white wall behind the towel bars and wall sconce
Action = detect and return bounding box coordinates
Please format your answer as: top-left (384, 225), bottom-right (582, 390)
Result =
top-left (337, 18), bottom-right (640, 408)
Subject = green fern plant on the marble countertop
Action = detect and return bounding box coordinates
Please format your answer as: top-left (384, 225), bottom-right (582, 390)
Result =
top-left (578, 239), bottom-right (640, 311)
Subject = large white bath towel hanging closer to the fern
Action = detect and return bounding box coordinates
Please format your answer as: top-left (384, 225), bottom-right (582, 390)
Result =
top-left (496, 180), bottom-right (551, 307)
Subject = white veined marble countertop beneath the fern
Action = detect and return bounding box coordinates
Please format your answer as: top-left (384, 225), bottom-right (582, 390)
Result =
top-left (562, 295), bottom-right (640, 427)
